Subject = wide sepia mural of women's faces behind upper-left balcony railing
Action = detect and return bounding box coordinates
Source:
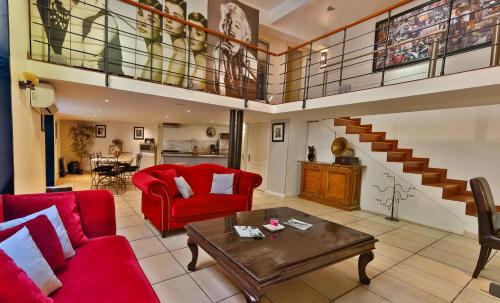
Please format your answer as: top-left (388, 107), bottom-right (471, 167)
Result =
top-left (31, 0), bottom-right (208, 90)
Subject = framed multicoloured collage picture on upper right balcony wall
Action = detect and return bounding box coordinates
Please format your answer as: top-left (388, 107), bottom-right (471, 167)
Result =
top-left (373, 0), bottom-right (500, 72)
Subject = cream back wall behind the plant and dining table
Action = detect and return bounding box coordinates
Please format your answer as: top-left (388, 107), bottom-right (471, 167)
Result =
top-left (59, 120), bottom-right (158, 170)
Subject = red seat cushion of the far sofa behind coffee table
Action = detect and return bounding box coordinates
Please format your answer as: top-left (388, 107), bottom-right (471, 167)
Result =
top-left (172, 194), bottom-right (247, 218)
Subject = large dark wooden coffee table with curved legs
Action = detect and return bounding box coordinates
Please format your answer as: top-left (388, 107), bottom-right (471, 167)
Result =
top-left (186, 207), bottom-right (377, 302)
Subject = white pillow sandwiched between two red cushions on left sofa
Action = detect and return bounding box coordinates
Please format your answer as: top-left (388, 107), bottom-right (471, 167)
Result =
top-left (0, 205), bottom-right (75, 259)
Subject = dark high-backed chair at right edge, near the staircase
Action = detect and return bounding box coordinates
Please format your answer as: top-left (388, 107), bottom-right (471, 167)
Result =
top-left (470, 177), bottom-right (500, 278)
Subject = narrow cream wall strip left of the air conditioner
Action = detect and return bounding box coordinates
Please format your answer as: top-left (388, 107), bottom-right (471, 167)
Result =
top-left (9, 1), bottom-right (45, 194)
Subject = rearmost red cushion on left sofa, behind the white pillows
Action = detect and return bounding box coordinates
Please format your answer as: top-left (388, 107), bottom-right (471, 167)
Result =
top-left (4, 192), bottom-right (88, 247)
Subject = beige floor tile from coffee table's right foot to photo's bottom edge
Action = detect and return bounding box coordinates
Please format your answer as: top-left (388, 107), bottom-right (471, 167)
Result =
top-left (363, 273), bottom-right (446, 303)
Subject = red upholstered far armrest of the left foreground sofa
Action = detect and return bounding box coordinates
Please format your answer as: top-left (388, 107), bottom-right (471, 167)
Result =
top-left (75, 190), bottom-right (116, 238)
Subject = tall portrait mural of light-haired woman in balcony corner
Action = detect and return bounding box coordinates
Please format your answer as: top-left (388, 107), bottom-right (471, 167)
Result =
top-left (207, 0), bottom-right (259, 100)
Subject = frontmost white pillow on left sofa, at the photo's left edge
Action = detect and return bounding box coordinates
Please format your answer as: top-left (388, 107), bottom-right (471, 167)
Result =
top-left (0, 227), bottom-right (62, 295)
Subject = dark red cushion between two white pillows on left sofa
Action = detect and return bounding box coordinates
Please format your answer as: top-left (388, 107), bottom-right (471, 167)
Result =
top-left (0, 215), bottom-right (65, 271)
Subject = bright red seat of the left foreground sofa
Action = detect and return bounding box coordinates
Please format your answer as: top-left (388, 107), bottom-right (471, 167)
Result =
top-left (52, 236), bottom-right (159, 303)
